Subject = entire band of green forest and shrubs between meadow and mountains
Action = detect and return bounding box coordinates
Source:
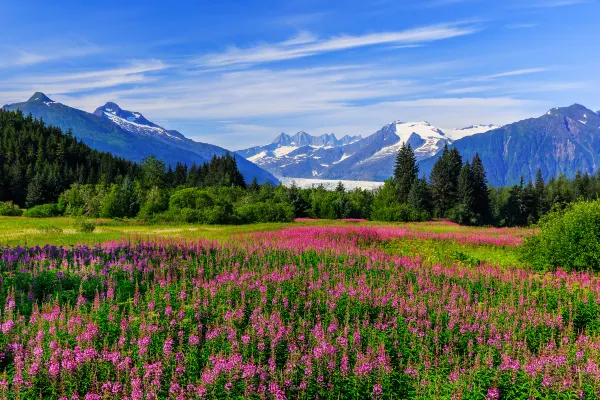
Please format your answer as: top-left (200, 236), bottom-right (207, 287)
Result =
top-left (0, 111), bottom-right (600, 226)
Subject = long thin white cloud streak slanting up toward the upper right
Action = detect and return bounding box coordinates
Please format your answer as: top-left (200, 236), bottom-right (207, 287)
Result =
top-left (198, 23), bottom-right (478, 68)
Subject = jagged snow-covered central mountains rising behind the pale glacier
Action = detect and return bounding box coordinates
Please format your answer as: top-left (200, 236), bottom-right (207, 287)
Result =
top-left (237, 121), bottom-right (497, 181)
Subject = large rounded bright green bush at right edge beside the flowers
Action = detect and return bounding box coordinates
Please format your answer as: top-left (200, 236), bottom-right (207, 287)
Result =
top-left (522, 200), bottom-right (600, 270)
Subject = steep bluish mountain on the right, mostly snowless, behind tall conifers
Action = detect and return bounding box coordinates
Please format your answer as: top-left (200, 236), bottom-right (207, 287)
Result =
top-left (419, 104), bottom-right (600, 186)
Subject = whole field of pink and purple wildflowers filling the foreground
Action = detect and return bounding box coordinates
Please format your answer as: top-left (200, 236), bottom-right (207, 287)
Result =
top-left (0, 221), bottom-right (600, 400)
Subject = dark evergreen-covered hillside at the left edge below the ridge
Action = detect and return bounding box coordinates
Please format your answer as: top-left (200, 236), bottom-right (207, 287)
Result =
top-left (0, 110), bottom-right (139, 206)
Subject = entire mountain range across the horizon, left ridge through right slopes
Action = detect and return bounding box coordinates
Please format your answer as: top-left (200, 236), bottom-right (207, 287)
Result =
top-left (3, 92), bottom-right (600, 186)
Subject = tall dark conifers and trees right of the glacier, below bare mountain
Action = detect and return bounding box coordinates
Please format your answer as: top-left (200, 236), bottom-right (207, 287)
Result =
top-left (386, 144), bottom-right (600, 226)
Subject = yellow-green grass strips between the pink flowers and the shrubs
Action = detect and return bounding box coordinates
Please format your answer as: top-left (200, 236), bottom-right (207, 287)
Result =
top-left (0, 217), bottom-right (526, 266)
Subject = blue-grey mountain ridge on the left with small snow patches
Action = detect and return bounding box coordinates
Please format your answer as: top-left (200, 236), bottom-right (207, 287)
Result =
top-left (3, 92), bottom-right (279, 184)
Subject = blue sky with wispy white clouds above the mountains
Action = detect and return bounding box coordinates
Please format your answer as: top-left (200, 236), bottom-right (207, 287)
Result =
top-left (0, 0), bottom-right (600, 150)
